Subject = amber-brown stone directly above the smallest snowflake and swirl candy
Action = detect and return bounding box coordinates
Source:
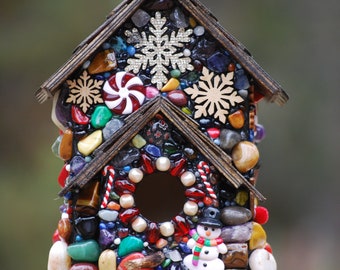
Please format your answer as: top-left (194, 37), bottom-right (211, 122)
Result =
top-left (87, 50), bottom-right (117, 74)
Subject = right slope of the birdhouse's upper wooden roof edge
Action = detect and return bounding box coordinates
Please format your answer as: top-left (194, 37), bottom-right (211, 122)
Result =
top-left (178, 0), bottom-right (289, 105)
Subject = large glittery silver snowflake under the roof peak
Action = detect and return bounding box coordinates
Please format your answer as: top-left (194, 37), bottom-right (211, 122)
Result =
top-left (125, 12), bottom-right (193, 89)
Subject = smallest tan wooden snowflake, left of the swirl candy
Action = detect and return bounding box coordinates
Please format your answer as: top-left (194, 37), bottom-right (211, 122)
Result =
top-left (66, 70), bottom-right (104, 113)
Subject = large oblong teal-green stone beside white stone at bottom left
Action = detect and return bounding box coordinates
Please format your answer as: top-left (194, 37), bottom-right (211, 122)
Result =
top-left (67, 240), bottom-right (100, 262)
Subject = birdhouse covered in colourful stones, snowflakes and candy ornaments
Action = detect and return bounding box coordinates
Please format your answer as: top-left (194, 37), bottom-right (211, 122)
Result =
top-left (36, 0), bottom-right (288, 270)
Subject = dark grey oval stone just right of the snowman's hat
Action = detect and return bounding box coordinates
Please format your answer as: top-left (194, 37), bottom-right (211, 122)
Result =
top-left (221, 206), bottom-right (252, 225)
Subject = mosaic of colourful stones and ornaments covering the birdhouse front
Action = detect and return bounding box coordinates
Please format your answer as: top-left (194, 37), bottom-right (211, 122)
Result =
top-left (48, 0), bottom-right (276, 270)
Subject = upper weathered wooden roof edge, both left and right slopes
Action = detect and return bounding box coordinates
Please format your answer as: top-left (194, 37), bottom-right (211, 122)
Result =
top-left (35, 0), bottom-right (289, 105)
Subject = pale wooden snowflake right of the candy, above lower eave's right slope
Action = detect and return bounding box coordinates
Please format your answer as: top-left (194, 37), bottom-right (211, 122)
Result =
top-left (184, 67), bottom-right (244, 124)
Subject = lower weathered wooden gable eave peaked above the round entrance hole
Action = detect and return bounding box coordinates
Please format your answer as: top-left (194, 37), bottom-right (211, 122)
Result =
top-left (59, 96), bottom-right (265, 201)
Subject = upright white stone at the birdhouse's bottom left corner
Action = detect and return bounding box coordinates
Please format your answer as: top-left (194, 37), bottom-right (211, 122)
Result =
top-left (47, 241), bottom-right (71, 270)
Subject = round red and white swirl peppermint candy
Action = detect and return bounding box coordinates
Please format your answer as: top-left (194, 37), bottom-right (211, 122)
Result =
top-left (103, 71), bottom-right (145, 114)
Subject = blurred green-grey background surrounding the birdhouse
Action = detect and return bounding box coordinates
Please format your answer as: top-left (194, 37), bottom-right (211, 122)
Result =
top-left (0, 0), bottom-right (340, 270)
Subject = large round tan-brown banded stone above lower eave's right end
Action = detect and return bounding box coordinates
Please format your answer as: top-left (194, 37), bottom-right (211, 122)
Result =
top-left (231, 141), bottom-right (260, 173)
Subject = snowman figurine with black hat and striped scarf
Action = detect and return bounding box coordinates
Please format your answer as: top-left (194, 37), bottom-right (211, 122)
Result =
top-left (183, 207), bottom-right (228, 270)
